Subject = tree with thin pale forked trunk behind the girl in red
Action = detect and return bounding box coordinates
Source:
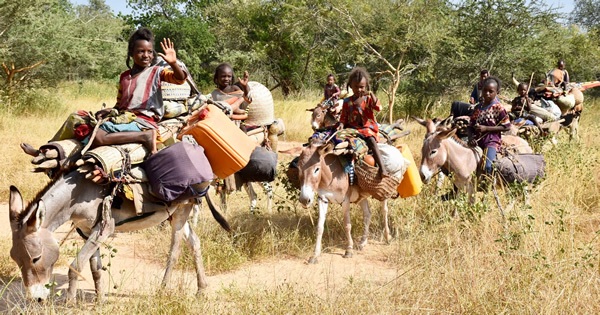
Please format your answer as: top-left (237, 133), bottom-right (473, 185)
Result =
top-left (329, 0), bottom-right (455, 123)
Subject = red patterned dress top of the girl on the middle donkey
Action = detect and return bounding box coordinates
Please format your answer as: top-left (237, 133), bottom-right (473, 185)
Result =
top-left (340, 96), bottom-right (381, 139)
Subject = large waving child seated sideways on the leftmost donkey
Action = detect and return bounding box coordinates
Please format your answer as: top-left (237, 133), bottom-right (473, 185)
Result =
top-left (21, 28), bottom-right (188, 162)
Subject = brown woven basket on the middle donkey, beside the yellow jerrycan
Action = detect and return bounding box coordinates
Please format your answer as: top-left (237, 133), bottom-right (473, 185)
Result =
top-left (354, 161), bottom-right (400, 201)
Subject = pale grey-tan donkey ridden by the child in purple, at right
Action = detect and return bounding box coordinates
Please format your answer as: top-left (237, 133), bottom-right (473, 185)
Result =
top-left (415, 118), bottom-right (533, 202)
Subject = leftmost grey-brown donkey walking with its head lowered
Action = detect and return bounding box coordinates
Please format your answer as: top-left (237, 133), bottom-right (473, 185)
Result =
top-left (9, 170), bottom-right (231, 301)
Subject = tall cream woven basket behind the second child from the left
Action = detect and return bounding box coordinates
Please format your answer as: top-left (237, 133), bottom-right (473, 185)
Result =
top-left (246, 81), bottom-right (275, 126)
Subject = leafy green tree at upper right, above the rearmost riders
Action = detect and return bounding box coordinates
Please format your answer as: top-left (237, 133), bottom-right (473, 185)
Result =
top-left (453, 0), bottom-right (564, 87)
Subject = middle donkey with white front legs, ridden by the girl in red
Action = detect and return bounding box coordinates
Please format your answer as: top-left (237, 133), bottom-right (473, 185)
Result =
top-left (298, 141), bottom-right (391, 264)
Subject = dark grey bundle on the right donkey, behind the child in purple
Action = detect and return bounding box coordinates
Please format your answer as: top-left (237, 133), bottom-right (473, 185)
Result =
top-left (494, 154), bottom-right (546, 183)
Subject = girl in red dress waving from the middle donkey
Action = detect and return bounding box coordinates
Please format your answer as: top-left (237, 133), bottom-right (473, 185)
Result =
top-left (339, 67), bottom-right (388, 177)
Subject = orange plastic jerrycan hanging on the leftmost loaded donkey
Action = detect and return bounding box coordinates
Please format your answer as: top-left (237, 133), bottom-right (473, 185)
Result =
top-left (178, 105), bottom-right (257, 178)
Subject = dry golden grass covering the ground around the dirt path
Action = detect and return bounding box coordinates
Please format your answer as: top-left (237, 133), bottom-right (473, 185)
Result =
top-left (0, 81), bottom-right (600, 314)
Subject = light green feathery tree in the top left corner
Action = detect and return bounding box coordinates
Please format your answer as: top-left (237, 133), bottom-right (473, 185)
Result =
top-left (0, 0), bottom-right (124, 91)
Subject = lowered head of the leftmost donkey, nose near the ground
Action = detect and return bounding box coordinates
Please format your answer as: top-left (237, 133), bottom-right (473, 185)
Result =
top-left (9, 186), bottom-right (59, 301)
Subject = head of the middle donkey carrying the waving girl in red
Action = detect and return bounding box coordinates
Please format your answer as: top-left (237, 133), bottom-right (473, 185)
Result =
top-left (298, 142), bottom-right (333, 207)
